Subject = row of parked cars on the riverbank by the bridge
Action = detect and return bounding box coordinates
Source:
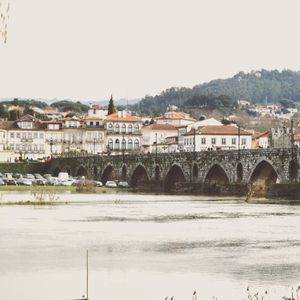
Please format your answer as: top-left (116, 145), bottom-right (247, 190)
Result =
top-left (0, 172), bottom-right (129, 188)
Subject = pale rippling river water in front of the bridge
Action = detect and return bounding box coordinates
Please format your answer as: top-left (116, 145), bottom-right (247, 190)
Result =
top-left (0, 193), bottom-right (300, 300)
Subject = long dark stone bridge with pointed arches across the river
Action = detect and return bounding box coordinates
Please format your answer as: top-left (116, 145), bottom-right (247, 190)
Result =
top-left (50, 148), bottom-right (300, 195)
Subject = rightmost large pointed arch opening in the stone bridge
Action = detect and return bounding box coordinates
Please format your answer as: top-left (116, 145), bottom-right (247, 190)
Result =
top-left (249, 159), bottom-right (279, 188)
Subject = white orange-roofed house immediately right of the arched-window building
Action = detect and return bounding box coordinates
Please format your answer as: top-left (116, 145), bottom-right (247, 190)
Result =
top-left (142, 124), bottom-right (178, 153)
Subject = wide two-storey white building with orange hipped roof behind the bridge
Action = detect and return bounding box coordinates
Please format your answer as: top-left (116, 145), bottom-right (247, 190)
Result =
top-left (183, 125), bottom-right (252, 152)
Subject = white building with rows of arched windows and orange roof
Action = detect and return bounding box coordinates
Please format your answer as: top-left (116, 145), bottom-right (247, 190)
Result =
top-left (105, 110), bottom-right (142, 154)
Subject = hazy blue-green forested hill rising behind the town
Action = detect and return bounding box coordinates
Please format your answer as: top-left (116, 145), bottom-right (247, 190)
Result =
top-left (134, 69), bottom-right (300, 114)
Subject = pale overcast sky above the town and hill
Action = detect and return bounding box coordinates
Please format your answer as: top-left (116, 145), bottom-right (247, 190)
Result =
top-left (0, 0), bottom-right (300, 100)
